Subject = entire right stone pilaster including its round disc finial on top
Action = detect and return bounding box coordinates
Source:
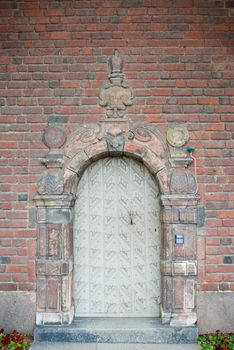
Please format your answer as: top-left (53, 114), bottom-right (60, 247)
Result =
top-left (161, 124), bottom-right (199, 327)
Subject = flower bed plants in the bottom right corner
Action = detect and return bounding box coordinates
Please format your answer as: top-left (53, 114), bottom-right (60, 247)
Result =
top-left (198, 330), bottom-right (234, 350)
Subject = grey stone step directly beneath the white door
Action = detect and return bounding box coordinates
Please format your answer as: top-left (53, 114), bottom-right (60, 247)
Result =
top-left (34, 317), bottom-right (197, 344)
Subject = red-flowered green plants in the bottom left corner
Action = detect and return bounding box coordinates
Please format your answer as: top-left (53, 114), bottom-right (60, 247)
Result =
top-left (0, 328), bottom-right (30, 350)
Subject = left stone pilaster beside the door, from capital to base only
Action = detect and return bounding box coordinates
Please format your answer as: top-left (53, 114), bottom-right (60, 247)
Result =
top-left (35, 195), bottom-right (74, 325)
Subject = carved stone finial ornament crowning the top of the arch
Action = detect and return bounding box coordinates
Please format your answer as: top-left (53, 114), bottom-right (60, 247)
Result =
top-left (100, 49), bottom-right (133, 118)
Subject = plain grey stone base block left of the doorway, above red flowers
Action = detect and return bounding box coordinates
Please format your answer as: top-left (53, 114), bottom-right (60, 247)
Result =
top-left (0, 291), bottom-right (36, 334)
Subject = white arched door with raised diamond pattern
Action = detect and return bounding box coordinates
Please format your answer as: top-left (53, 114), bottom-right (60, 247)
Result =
top-left (74, 157), bottom-right (161, 317)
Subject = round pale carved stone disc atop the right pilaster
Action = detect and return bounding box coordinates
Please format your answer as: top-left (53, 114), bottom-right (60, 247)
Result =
top-left (167, 124), bottom-right (189, 147)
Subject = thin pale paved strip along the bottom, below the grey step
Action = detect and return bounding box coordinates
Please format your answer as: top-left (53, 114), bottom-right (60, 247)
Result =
top-left (30, 342), bottom-right (200, 350)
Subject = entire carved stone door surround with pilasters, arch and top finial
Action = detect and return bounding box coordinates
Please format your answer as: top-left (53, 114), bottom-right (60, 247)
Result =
top-left (35, 52), bottom-right (199, 326)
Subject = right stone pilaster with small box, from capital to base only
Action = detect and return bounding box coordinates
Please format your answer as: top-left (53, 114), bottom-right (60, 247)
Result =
top-left (161, 195), bottom-right (198, 326)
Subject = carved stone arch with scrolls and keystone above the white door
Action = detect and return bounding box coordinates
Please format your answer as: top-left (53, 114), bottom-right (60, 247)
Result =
top-left (64, 119), bottom-right (170, 194)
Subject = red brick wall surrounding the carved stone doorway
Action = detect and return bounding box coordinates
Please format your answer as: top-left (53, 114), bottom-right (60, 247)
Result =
top-left (0, 0), bottom-right (234, 291)
